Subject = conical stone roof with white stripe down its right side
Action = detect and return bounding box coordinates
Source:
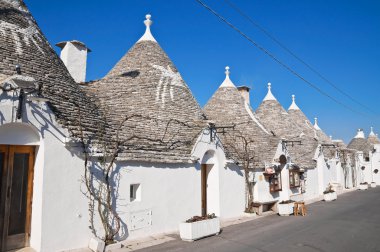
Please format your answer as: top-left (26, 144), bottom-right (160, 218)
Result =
top-left (203, 69), bottom-right (280, 168)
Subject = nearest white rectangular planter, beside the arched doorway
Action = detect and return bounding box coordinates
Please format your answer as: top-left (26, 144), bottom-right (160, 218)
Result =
top-left (179, 214), bottom-right (220, 241)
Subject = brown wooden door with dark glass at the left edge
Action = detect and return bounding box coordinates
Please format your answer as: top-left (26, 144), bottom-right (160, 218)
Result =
top-left (0, 145), bottom-right (35, 251)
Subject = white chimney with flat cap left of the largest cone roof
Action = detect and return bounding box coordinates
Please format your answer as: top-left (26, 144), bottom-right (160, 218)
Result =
top-left (56, 40), bottom-right (91, 83)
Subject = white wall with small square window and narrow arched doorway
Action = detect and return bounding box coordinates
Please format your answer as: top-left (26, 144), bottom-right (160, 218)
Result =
top-left (118, 132), bottom-right (245, 239)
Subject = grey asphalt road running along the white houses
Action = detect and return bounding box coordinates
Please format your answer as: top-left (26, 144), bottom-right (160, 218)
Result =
top-left (139, 187), bottom-right (380, 252)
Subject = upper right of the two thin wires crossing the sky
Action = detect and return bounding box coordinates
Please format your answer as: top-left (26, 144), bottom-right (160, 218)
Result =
top-left (224, 0), bottom-right (377, 114)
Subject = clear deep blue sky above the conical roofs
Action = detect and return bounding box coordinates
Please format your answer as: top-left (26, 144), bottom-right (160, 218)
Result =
top-left (25, 0), bottom-right (380, 143)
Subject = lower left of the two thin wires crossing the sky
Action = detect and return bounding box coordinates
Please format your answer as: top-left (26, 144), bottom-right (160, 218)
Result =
top-left (195, 0), bottom-right (369, 117)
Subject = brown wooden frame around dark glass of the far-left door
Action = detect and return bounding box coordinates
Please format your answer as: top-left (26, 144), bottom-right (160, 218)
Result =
top-left (0, 145), bottom-right (36, 251)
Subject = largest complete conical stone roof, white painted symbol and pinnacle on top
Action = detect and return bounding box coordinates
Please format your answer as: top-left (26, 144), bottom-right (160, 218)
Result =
top-left (85, 15), bottom-right (206, 162)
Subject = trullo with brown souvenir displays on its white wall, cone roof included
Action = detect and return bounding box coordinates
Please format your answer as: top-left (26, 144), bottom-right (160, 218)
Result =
top-left (204, 73), bottom-right (300, 215)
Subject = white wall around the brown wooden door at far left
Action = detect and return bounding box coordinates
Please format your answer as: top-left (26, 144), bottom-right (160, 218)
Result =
top-left (0, 94), bottom-right (90, 252)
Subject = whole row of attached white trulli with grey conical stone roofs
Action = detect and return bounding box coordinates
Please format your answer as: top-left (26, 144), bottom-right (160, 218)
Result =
top-left (0, 0), bottom-right (380, 252)
